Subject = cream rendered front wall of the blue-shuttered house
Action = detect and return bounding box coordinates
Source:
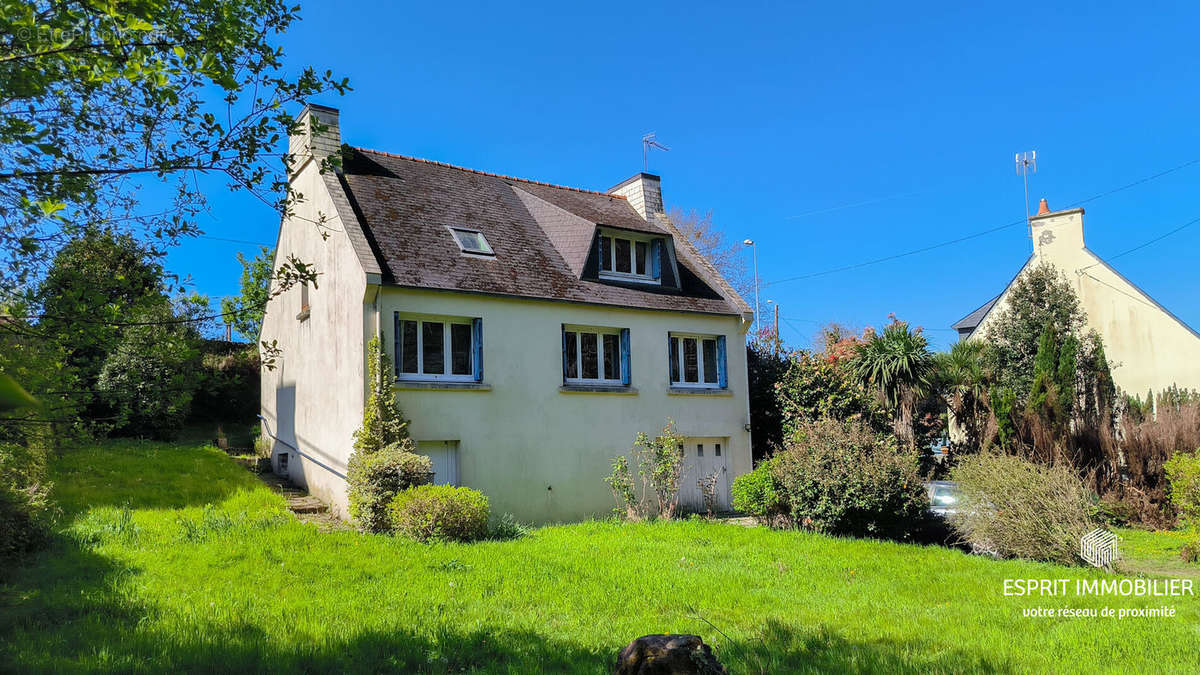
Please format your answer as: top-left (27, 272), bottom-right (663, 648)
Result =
top-left (380, 288), bottom-right (751, 522)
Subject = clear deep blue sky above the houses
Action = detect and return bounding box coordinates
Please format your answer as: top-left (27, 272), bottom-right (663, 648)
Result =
top-left (168, 2), bottom-right (1200, 347)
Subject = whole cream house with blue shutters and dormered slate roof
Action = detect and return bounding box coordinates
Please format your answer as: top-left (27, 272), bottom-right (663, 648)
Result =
top-left (260, 106), bottom-right (752, 522)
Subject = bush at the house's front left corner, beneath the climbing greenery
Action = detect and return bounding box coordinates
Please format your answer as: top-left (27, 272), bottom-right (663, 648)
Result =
top-left (347, 438), bottom-right (433, 532)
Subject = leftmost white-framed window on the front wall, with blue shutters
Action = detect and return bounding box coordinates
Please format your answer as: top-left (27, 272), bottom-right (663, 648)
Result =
top-left (395, 312), bottom-right (484, 382)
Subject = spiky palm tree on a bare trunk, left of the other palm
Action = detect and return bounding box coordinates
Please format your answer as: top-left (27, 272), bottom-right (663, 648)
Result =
top-left (853, 321), bottom-right (934, 444)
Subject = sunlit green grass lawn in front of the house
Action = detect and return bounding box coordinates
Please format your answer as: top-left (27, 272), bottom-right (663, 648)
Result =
top-left (0, 442), bottom-right (1200, 673)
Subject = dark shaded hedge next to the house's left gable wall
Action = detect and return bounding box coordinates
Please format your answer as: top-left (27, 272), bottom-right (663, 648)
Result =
top-left (188, 340), bottom-right (262, 424)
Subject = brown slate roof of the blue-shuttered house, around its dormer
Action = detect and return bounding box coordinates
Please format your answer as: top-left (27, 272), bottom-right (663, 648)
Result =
top-left (335, 148), bottom-right (746, 315)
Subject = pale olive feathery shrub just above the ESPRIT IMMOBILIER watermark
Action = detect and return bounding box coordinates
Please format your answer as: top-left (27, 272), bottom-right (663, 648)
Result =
top-left (950, 453), bottom-right (1097, 565)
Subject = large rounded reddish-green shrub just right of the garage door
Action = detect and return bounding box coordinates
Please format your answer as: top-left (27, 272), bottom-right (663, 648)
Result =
top-left (769, 418), bottom-right (929, 539)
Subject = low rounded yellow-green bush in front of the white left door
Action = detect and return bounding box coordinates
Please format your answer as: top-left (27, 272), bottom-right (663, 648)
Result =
top-left (389, 485), bottom-right (488, 542)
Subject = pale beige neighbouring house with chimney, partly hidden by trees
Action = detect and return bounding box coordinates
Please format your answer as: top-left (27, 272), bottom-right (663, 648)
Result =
top-left (954, 199), bottom-right (1200, 396)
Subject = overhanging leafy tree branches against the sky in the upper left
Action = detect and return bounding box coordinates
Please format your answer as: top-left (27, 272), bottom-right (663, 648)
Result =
top-left (0, 0), bottom-right (348, 291)
